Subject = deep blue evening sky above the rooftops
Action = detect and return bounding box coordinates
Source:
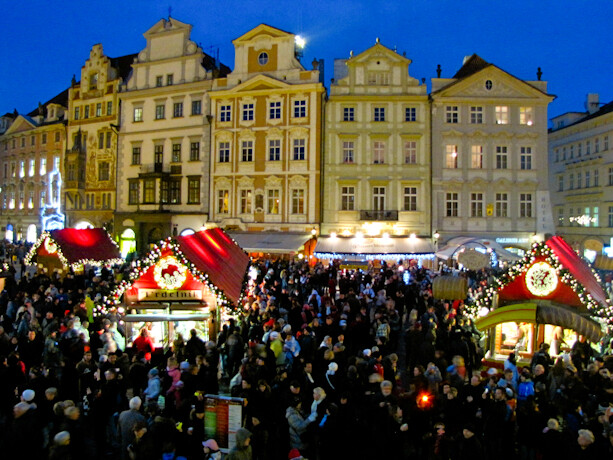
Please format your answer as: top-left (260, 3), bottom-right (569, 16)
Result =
top-left (0, 0), bottom-right (613, 117)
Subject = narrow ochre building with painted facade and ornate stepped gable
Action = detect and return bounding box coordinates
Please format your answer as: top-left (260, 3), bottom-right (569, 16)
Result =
top-left (63, 44), bottom-right (136, 232)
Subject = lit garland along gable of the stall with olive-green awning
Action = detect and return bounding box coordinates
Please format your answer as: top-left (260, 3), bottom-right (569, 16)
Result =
top-left (465, 243), bottom-right (613, 324)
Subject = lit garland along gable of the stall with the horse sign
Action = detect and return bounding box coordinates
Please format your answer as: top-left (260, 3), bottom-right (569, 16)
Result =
top-left (94, 237), bottom-right (242, 316)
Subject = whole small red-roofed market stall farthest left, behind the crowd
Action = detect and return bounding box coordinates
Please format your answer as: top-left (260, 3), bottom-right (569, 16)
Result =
top-left (25, 228), bottom-right (123, 273)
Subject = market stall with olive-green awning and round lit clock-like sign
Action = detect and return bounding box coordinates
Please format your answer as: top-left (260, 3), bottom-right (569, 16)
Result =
top-left (468, 236), bottom-right (613, 364)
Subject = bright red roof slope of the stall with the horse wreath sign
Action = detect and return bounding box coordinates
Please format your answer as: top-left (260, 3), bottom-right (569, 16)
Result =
top-left (175, 228), bottom-right (249, 303)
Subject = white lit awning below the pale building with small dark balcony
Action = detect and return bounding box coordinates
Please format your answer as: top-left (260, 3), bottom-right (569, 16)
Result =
top-left (315, 236), bottom-right (434, 258)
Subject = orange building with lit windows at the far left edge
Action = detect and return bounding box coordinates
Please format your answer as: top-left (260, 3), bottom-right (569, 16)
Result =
top-left (0, 90), bottom-right (68, 243)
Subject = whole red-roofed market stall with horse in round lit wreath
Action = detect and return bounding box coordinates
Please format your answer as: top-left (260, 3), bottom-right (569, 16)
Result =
top-left (97, 228), bottom-right (249, 348)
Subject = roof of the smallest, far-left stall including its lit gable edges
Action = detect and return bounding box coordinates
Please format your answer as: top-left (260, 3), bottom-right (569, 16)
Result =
top-left (29, 228), bottom-right (121, 266)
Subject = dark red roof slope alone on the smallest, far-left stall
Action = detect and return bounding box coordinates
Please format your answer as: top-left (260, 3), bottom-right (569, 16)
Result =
top-left (49, 228), bottom-right (120, 265)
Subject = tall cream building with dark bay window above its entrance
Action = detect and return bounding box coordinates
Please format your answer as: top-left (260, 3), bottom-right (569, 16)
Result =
top-left (115, 18), bottom-right (228, 255)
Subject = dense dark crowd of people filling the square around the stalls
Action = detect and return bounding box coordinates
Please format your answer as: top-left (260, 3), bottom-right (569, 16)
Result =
top-left (0, 243), bottom-right (613, 460)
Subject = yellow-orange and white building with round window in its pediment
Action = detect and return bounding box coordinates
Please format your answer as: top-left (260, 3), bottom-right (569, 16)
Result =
top-left (210, 24), bottom-right (325, 246)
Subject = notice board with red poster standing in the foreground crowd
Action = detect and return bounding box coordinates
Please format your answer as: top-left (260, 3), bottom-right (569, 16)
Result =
top-left (204, 394), bottom-right (244, 452)
